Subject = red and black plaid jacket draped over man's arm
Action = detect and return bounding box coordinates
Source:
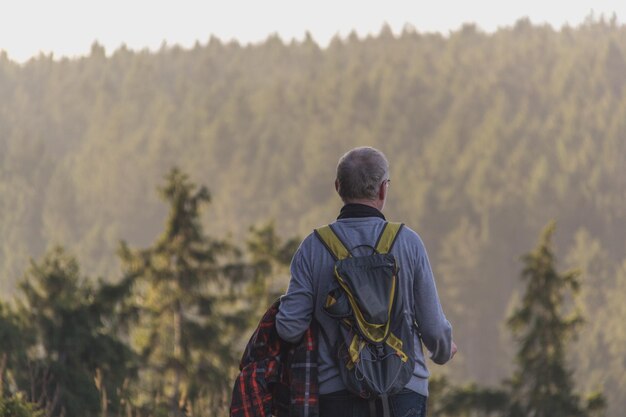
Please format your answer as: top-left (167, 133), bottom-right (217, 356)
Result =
top-left (230, 301), bottom-right (319, 417)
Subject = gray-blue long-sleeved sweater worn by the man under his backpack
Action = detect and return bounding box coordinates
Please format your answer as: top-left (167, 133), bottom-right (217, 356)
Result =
top-left (276, 217), bottom-right (452, 396)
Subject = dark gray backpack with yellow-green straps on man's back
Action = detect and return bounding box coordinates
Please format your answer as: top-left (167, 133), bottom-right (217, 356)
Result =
top-left (315, 223), bottom-right (415, 417)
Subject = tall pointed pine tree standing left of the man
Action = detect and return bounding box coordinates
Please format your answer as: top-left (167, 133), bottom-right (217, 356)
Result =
top-left (120, 168), bottom-right (255, 416)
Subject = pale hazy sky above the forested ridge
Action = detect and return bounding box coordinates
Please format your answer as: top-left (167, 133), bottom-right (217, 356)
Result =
top-left (0, 0), bottom-right (626, 62)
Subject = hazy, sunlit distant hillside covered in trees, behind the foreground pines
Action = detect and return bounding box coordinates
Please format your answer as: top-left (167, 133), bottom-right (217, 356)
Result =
top-left (0, 19), bottom-right (626, 417)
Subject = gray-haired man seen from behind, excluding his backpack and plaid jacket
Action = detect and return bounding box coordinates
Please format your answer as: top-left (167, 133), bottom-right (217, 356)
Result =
top-left (276, 147), bottom-right (456, 417)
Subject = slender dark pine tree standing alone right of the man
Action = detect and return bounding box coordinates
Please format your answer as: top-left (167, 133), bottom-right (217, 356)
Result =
top-left (508, 223), bottom-right (602, 417)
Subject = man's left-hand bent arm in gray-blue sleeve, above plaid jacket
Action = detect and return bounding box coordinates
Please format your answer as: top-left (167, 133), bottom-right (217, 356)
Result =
top-left (276, 237), bottom-right (315, 343)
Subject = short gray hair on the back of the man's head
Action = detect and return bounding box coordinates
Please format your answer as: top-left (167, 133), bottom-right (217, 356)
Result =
top-left (337, 146), bottom-right (389, 201)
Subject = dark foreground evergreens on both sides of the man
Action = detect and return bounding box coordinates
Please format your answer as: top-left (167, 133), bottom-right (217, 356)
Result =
top-left (0, 169), bottom-right (606, 417)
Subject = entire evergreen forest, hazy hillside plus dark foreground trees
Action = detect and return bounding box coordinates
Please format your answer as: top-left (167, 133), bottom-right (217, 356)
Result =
top-left (0, 16), bottom-right (626, 417)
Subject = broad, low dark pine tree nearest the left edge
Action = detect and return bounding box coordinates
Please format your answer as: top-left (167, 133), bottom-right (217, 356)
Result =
top-left (14, 247), bottom-right (133, 417)
